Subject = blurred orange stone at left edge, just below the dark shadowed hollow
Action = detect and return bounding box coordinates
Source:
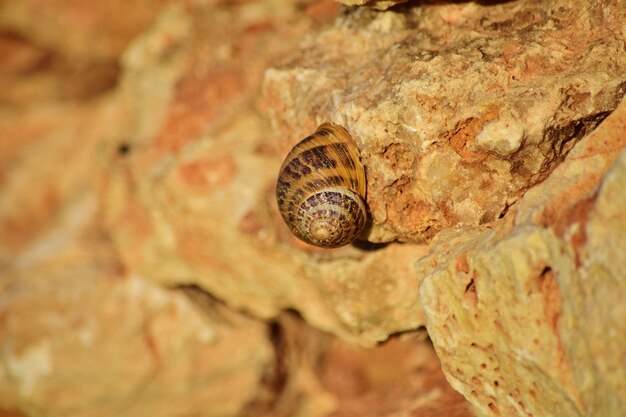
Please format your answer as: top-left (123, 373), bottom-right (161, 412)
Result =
top-left (0, 72), bottom-right (111, 258)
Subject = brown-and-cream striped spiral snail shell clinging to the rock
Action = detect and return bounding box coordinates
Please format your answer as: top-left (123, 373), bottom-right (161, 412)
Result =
top-left (276, 123), bottom-right (367, 248)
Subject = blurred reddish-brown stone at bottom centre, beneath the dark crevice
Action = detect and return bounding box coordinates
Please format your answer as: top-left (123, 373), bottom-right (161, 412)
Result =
top-left (250, 313), bottom-right (473, 417)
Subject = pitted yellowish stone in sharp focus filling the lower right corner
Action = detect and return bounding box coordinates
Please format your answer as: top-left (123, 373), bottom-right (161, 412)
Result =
top-left (418, 97), bottom-right (626, 416)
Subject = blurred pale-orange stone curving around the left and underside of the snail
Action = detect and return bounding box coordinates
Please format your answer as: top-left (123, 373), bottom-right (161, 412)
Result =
top-left (102, 2), bottom-right (426, 345)
